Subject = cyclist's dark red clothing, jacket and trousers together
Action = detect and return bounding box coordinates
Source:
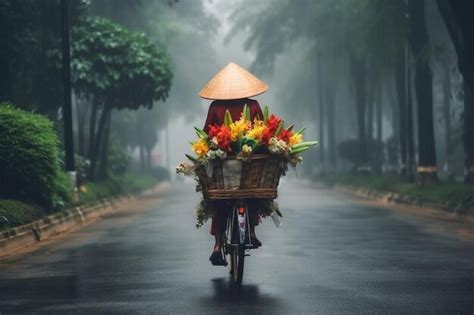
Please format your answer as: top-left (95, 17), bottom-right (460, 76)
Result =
top-left (204, 98), bottom-right (263, 235)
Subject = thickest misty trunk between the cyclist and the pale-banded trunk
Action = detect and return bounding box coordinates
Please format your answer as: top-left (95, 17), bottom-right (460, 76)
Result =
top-left (350, 52), bottom-right (367, 171)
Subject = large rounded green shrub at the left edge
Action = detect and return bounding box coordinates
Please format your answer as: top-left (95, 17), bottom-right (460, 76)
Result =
top-left (0, 103), bottom-right (59, 206)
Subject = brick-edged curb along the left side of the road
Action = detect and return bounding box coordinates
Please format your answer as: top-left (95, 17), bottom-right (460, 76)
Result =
top-left (0, 196), bottom-right (135, 258)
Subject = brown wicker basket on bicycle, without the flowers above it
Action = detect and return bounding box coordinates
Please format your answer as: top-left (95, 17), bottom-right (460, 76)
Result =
top-left (196, 154), bottom-right (282, 200)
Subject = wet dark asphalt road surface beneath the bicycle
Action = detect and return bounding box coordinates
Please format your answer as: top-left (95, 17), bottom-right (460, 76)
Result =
top-left (0, 181), bottom-right (474, 314)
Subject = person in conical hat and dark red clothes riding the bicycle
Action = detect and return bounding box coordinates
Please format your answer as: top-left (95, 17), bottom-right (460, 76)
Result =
top-left (199, 62), bottom-right (268, 265)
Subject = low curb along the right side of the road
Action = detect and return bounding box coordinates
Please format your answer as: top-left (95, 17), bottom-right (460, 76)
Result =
top-left (334, 185), bottom-right (474, 223)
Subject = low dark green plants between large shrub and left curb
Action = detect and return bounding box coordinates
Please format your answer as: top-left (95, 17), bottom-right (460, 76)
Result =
top-left (0, 199), bottom-right (47, 230)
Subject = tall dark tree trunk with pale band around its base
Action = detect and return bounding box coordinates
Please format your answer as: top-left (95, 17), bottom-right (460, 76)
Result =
top-left (408, 0), bottom-right (438, 185)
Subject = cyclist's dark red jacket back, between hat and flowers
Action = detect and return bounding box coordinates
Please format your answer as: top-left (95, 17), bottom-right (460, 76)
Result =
top-left (204, 98), bottom-right (263, 133)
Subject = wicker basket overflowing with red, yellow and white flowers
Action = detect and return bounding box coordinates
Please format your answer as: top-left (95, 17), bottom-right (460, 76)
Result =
top-left (176, 105), bottom-right (317, 226)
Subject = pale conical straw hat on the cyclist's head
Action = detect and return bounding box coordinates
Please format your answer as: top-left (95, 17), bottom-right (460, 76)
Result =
top-left (199, 62), bottom-right (268, 100)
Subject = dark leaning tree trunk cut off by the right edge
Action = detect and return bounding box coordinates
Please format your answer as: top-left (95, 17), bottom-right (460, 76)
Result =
top-left (437, 0), bottom-right (474, 183)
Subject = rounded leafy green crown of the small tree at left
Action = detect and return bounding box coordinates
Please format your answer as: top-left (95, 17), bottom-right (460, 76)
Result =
top-left (71, 17), bottom-right (172, 109)
